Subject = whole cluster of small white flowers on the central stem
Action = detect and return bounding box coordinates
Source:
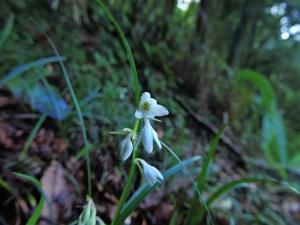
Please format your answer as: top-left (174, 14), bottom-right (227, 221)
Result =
top-left (119, 92), bottom-right (169, 185)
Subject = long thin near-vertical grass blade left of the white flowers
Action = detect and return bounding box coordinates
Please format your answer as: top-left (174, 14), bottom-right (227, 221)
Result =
top-left (35, 23), bottom-right (92, 197)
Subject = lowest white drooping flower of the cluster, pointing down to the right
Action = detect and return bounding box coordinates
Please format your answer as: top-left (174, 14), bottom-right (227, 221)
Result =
top-left (137, 159), bottom-right (164, 185)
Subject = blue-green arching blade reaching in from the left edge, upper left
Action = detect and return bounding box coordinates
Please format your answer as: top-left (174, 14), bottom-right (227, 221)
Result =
top-left (0, 56), bottom-right (65, 86)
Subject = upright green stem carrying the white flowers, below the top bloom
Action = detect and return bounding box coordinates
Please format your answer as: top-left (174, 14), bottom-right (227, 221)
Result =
top-left (111, 120), bottom-right (139, 225)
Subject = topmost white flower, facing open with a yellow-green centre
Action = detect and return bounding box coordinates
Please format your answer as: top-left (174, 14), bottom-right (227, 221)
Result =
top-left (135, 92), bottom-right (169, 119)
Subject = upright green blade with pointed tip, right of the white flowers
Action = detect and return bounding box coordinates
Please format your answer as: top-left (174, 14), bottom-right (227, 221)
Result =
top-left (186, 126), bottom-right (226, 224)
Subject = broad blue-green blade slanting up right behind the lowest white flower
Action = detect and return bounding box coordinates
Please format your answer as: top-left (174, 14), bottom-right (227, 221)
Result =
top-left (117, 156), bottom-right (201, 224)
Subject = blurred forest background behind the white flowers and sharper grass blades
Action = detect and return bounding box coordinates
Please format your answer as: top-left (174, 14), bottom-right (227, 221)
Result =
top-left (0, 0), bottom-right (300, 224)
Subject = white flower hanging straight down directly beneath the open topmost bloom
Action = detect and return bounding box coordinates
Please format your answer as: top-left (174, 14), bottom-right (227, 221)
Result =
top-left (139, 119), bottom-right (161, 153)
